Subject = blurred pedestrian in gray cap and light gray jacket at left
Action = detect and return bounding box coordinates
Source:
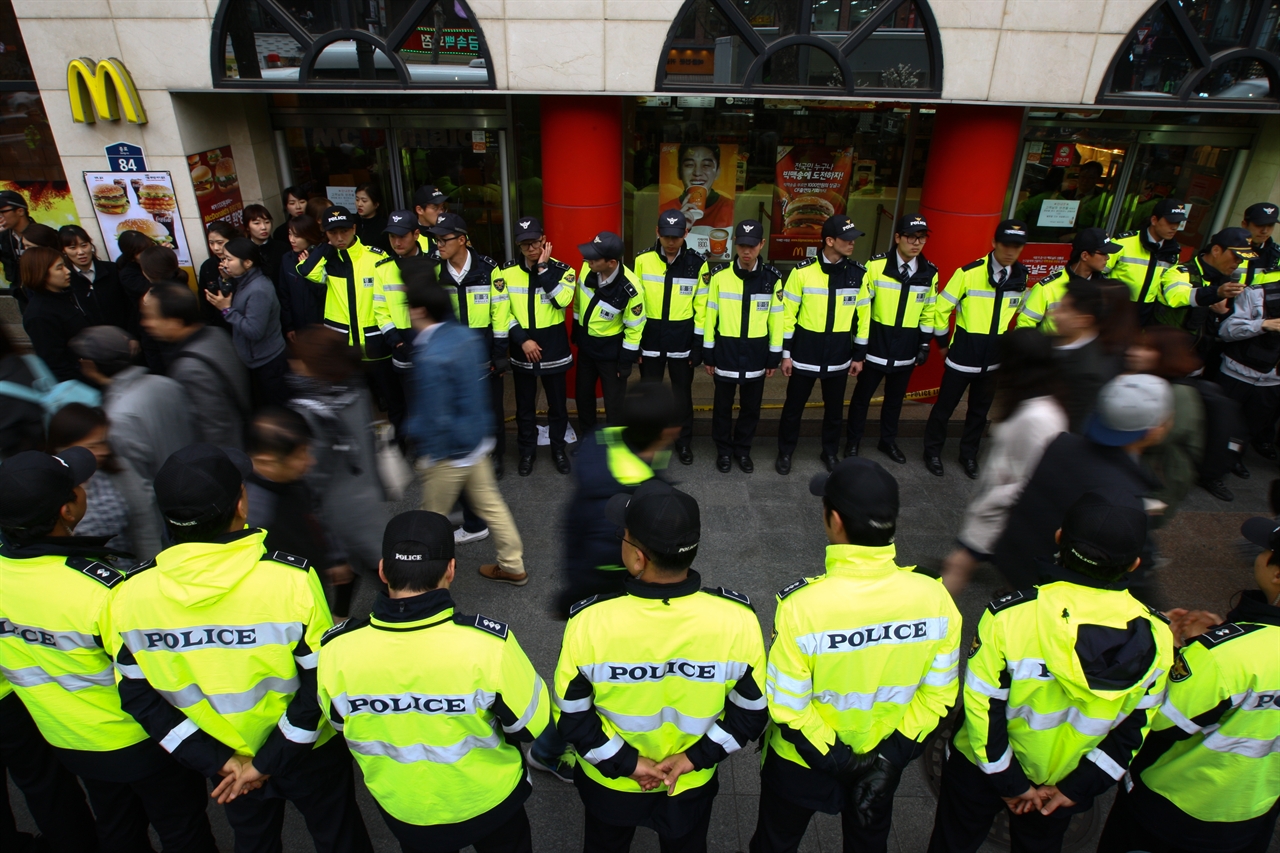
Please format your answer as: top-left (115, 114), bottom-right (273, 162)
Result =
top-left (72, 325), bottom-right (192, 484)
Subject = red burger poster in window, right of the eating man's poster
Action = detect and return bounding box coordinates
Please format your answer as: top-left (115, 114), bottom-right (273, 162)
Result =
top-left (769, 145), bottom-right (854, 261)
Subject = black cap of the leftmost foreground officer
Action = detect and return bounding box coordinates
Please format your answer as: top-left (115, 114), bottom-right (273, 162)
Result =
top-left (0, 447), bottom-right (97, 533)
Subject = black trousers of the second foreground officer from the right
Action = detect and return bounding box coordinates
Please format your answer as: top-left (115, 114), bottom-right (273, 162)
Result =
top-left (928, 744), bottom-right (1093, 853)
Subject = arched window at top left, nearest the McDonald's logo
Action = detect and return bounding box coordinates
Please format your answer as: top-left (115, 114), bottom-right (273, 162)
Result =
top-left (210, 0), bottom-right (494, 90)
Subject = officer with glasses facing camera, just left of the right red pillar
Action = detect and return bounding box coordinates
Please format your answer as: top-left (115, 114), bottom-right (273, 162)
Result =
top-left (845, 214), bottom-right (938, 465)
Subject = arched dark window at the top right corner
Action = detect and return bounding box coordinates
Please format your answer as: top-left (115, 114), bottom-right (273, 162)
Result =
top-left (1098, 0), bottom-right (1280, 110)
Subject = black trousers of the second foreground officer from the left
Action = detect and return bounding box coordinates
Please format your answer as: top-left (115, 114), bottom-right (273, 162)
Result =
top-left (218, 735), bottom-right (374, 853)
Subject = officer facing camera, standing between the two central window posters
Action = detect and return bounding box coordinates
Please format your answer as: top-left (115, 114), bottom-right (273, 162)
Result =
top-left (703, 219), bottom-right (786, 474)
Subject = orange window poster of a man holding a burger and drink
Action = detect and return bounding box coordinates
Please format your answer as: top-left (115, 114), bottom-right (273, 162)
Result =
top-left (654, 142), bottom-right (737, 260)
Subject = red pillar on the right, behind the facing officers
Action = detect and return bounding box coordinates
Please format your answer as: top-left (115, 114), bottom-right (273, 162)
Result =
top-left (911, 104), bottom-right (1023, 391)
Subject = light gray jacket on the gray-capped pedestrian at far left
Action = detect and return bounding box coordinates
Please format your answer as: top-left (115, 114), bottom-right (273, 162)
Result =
top-left (102, 366), bottom-right (196, 487)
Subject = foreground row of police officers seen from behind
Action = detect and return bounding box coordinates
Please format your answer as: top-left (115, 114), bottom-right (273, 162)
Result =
top-left (0, 432), bottom-right (1280, 853)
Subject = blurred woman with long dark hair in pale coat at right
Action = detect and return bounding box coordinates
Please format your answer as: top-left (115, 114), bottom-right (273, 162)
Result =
top-left (942, 328), bottom-right (1066, 596)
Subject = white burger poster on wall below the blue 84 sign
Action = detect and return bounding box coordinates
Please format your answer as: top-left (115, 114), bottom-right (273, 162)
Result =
top-left (84, 172), bottom-right (191, 266)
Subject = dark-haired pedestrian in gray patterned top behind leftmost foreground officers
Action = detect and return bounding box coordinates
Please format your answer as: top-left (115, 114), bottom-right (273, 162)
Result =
top-left (49, 403), bottom-right (163, 560)
